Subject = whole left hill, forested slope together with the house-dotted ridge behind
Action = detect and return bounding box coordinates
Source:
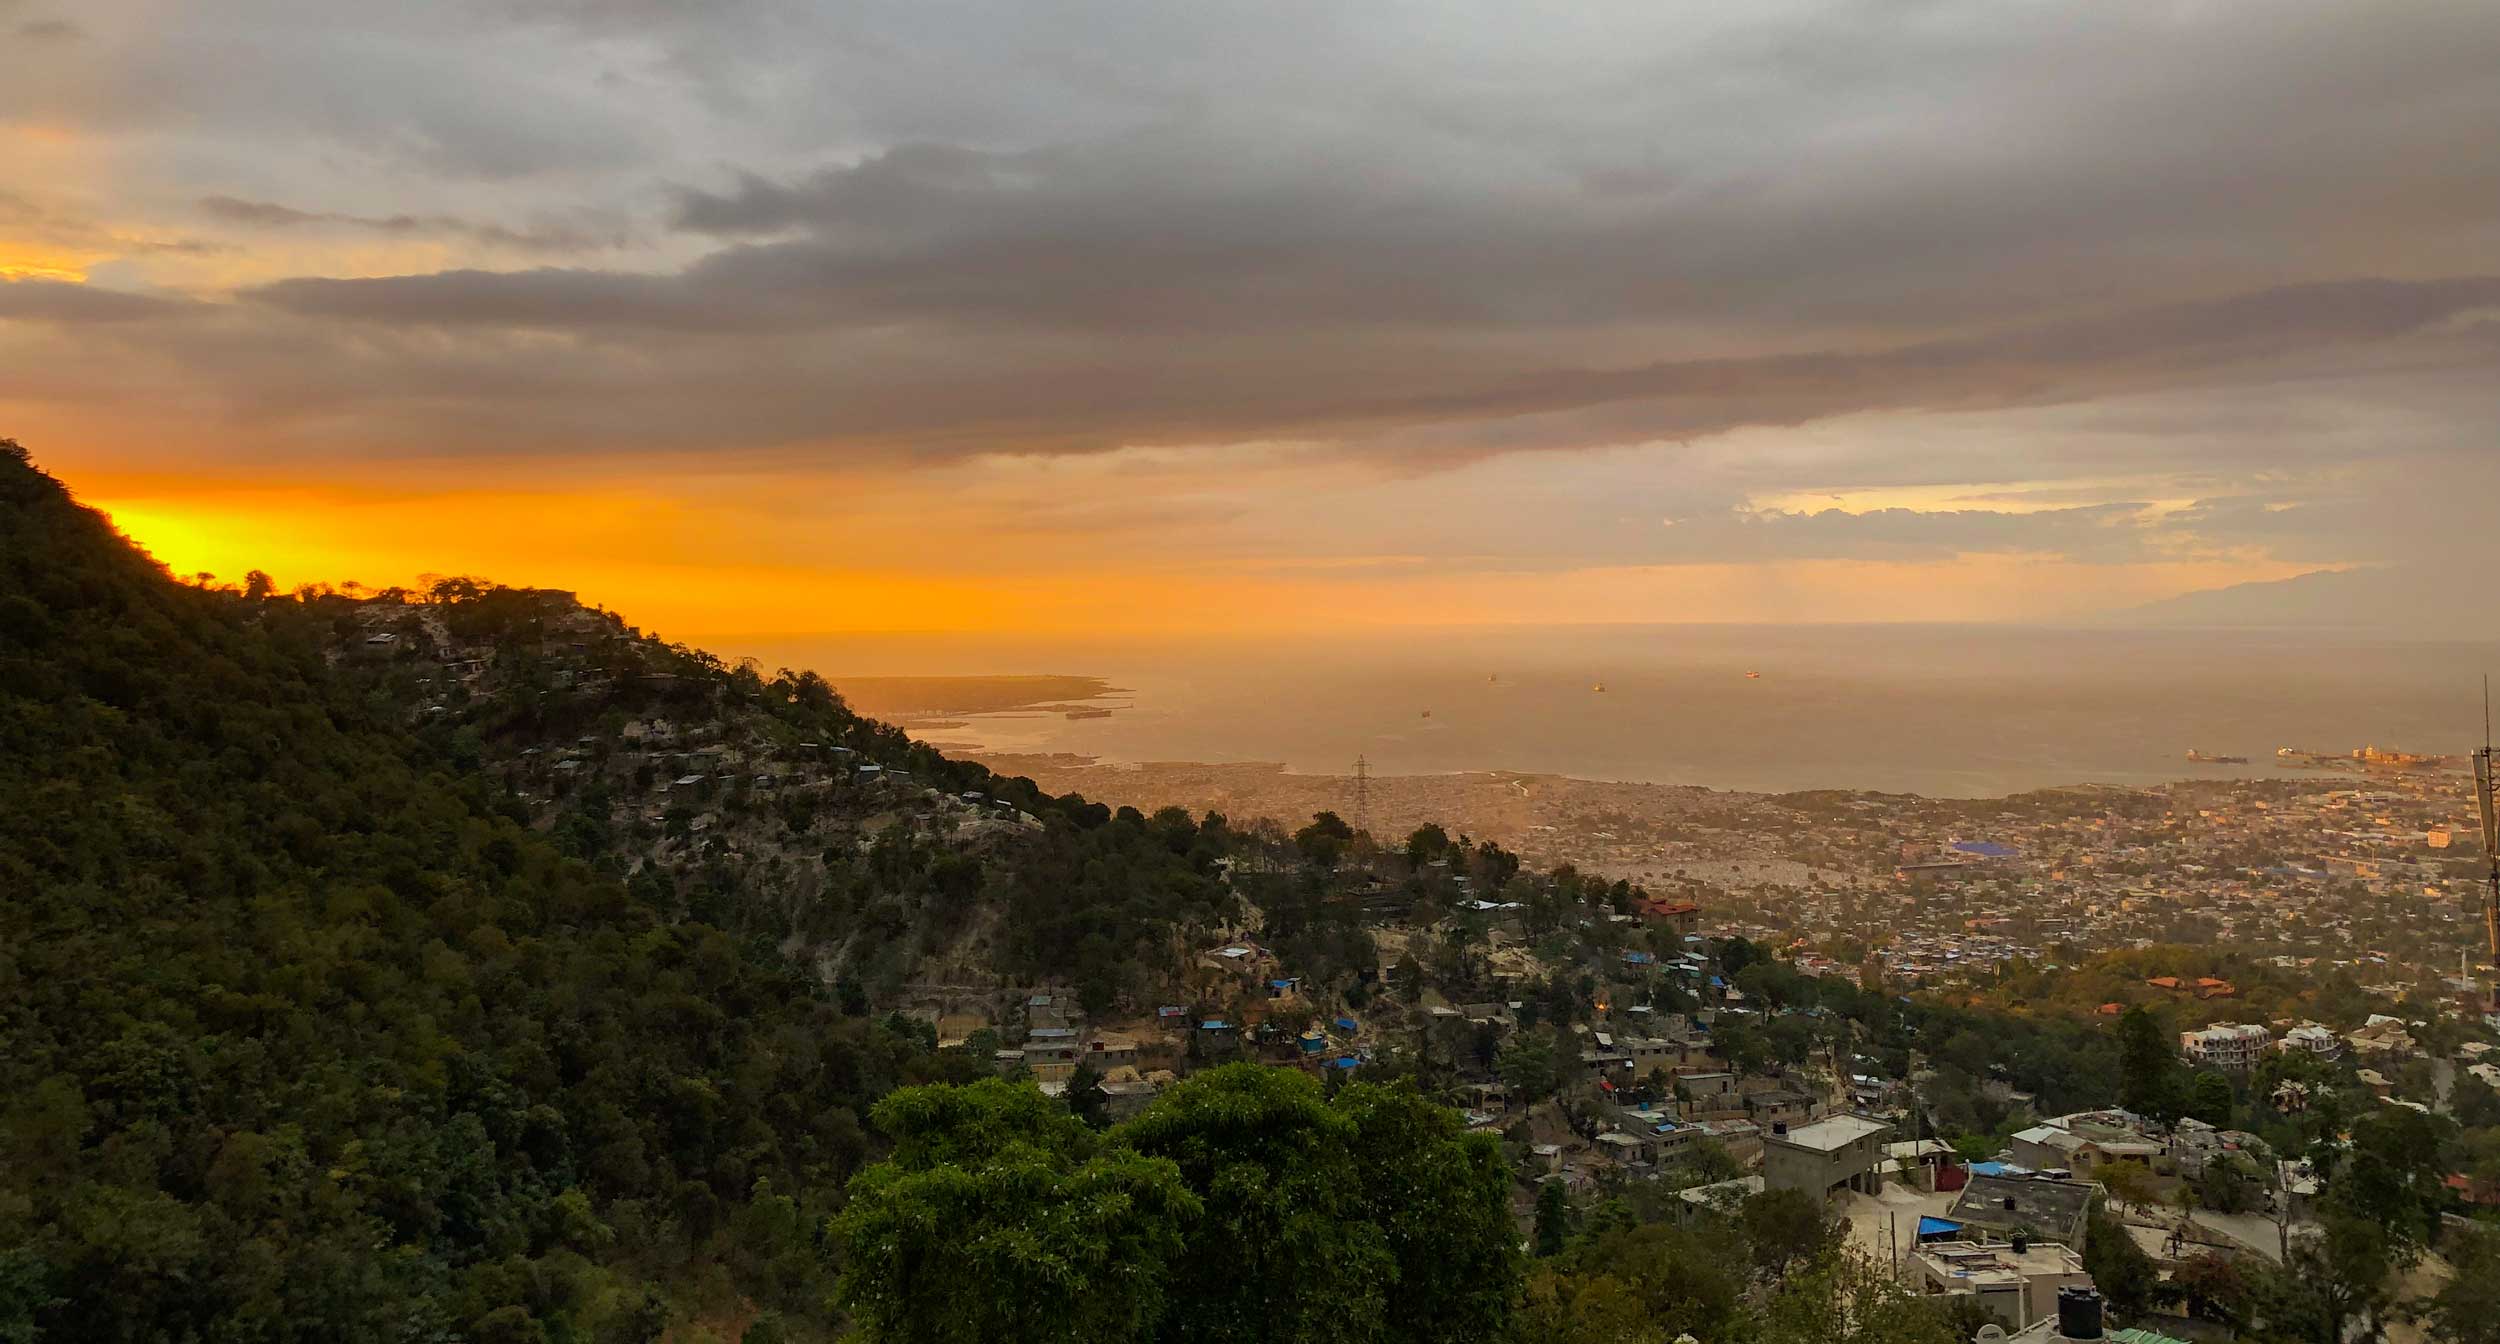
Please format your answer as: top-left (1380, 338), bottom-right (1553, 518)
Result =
top-left (0, 445), bottom-right (1240, 1339)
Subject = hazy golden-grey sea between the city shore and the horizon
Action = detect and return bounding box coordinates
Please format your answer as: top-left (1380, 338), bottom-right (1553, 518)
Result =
top-left (723, 625), bottom-right (2500, 797)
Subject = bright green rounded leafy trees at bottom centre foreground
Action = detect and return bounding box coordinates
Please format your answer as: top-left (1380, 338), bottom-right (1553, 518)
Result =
top-left (833, 1064), bottom-right (1520, 1344)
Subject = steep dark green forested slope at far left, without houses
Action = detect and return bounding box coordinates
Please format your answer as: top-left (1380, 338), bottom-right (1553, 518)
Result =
top-left (0, 445), bottom-right (995, 1342)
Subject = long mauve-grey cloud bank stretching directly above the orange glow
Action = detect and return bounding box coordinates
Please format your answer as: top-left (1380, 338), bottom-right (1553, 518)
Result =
top-left (107, 267), bottom-right (2500, 464)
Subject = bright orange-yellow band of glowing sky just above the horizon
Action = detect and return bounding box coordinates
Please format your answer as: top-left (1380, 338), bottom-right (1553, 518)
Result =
top-left (90, 477), bottom-right (2300, 645)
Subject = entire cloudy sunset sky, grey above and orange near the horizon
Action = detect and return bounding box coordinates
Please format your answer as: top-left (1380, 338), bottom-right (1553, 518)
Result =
top-left (0, 0), bottom-right (2500, 640)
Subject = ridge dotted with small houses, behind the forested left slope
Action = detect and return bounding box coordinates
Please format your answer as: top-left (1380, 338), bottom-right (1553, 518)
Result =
top-left (315, 580), bottom-right (1233, 1012)
